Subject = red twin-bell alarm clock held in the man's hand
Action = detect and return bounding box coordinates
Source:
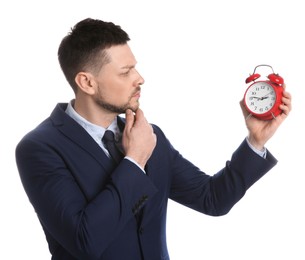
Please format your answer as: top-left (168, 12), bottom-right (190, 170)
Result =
top-left (243, 65), bottom-right (284, 120)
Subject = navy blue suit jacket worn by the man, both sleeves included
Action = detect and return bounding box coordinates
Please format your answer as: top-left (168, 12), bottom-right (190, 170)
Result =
top-left (16, 104), bottom-right (276, 260)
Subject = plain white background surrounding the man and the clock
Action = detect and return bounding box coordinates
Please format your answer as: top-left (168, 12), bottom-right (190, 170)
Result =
top-left (0, 0), bottom-right (305, 260)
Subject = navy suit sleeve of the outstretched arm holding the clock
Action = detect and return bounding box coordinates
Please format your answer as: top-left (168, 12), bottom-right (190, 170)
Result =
top-left (166, 136), bottom-right (277, 216)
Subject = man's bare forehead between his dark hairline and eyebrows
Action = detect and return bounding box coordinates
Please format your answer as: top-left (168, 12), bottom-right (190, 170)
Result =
top-left (107, 44), bottom-right (136, 67)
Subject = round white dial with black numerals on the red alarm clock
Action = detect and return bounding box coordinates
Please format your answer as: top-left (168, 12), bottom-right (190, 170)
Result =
top-left (245, 81), bottom-right (276, 114)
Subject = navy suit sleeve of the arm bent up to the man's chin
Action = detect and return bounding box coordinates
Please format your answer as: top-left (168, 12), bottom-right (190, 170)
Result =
top-left (16, 135), bottom-right (157, 259)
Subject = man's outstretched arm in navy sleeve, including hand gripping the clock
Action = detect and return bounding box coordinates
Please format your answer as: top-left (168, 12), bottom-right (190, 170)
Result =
top-left (167, 91), bottom-right (291, 215)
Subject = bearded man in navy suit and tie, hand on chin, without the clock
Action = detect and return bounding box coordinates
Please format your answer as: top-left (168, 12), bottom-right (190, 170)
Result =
top-left (16, 18), bottom-right (291, 260)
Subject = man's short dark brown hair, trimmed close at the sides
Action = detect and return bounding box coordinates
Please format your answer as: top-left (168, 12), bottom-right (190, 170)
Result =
top-left (58, 18), bottom-right (130, 92)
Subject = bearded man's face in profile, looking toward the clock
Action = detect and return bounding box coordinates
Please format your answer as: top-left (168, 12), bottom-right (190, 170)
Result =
top-left (94, 44), bottom-right (144, 114)
